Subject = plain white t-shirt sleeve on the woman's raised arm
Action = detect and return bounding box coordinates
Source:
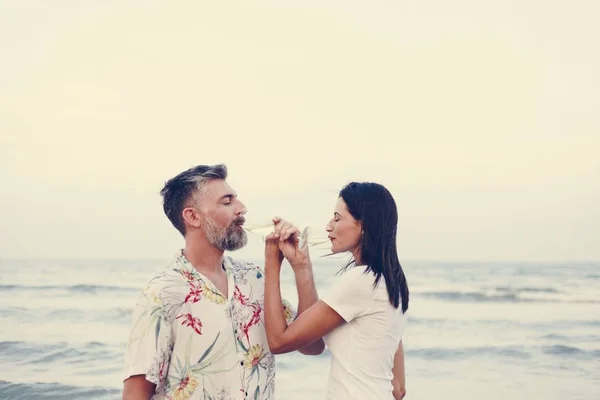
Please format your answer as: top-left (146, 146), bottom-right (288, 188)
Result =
top-left (321, 267), bottom-right (374, 322)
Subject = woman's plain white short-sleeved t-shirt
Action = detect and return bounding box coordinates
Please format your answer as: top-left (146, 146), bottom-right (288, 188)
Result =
top-left (322, 266), bottom-right (406, 400)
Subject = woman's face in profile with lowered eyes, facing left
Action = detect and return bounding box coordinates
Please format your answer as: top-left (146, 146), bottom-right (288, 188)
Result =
top-left (325, 197), bottom-right (362, 260)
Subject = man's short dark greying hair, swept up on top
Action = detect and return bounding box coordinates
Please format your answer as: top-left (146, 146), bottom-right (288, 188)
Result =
top-left (160, 164), bottom-right (227, 236)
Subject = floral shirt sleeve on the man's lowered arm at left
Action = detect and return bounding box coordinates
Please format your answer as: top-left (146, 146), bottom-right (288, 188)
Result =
top-left (123, 285), bottom-right (171, 390)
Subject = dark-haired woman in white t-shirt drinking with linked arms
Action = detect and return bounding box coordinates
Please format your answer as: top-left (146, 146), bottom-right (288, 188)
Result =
top-left (265, 182), bottom-right (408, 400)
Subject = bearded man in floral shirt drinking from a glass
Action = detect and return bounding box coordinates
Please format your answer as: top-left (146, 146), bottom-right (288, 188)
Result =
top-left (123, 164), bottom-right (324, 400)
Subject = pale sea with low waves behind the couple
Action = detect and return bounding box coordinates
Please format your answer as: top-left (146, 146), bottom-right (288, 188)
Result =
top-left (0, 258), bottom-right (600, 400)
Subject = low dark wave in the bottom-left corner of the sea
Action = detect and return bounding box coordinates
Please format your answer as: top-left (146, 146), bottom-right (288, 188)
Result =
top-left (0, 380), bottom-right (121, 400)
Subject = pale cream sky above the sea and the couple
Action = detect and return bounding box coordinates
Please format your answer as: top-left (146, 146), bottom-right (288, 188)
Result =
top-left (0, 0), bottom-right (600, 261)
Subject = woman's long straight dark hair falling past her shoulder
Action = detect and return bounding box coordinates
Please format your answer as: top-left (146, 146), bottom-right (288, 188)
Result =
top-left (339, 182), bottom-right (408, 313)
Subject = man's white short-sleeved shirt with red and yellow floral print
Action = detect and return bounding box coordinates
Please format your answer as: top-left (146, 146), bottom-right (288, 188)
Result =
top-left (125, 251), bottom-right (295, 400)
